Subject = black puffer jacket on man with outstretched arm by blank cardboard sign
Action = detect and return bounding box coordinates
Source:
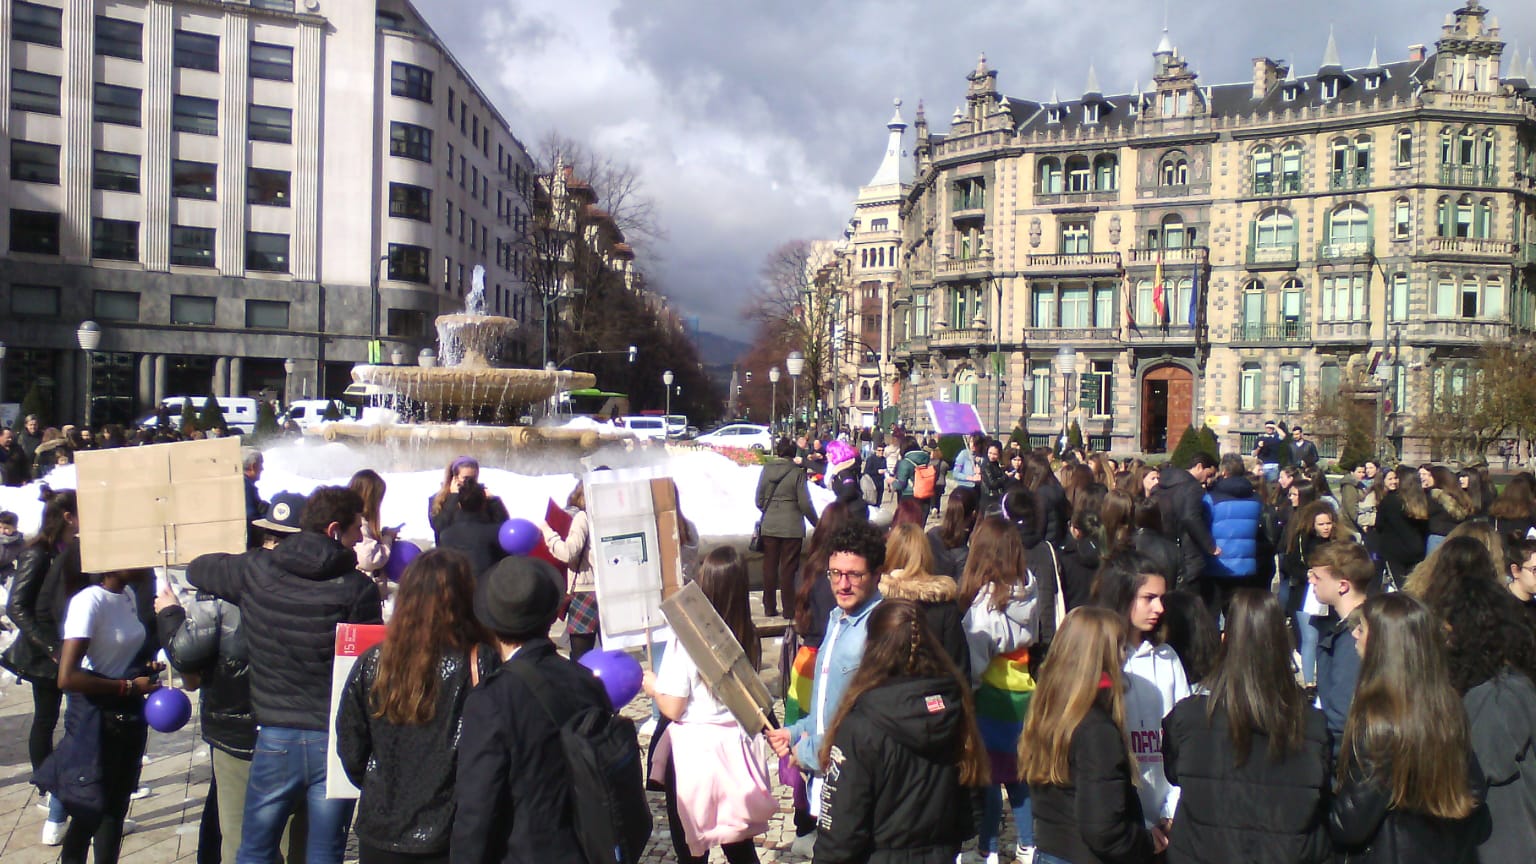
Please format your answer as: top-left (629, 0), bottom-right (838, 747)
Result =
top-left (187, 532), bottom-right (384, 730)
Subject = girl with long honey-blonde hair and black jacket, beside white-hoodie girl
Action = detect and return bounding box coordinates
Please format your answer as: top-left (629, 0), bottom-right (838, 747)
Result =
top-left (1018, 606), bottom-right (1167, 864)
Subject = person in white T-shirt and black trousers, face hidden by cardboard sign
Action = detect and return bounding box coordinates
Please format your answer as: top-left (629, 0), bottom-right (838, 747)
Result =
top-left (49, 570), bottom-right (160, 864)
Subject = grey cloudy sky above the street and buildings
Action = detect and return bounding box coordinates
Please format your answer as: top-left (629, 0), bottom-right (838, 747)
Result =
top-left (416, 0), bottom-right (1536, 338)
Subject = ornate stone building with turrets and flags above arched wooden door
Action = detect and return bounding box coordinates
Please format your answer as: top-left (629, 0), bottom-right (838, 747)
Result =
top-left (878, 0), bottom-right (1536, 458)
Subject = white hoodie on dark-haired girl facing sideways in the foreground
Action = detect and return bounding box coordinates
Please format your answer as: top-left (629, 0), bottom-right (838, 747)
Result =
top-left (1126, 641), bottom-right (1189, 826)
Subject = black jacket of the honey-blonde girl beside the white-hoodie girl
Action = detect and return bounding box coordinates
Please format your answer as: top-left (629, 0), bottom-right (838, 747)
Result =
top-left (1029, 701), bottom-right (1152, 864)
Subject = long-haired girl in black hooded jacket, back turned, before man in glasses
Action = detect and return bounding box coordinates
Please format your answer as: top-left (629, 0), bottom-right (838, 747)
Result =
top-left (816, 600), bottom-right (988, 861)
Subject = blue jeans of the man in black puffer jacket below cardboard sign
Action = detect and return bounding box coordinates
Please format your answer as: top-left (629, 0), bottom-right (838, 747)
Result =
top-left (237, 726), bottom-right (355, 864)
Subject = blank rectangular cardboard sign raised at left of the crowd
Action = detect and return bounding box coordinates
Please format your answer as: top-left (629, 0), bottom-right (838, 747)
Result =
top-left (75, 438), bottom-right (246, 573)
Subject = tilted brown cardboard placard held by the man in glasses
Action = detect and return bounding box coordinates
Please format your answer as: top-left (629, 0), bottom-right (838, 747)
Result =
top-left (662, 583), bottom-right (779, 733)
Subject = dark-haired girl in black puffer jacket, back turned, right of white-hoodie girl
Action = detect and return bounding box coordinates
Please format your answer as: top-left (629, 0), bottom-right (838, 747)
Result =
top-left (1163, 589), bottom-right (1333, 864)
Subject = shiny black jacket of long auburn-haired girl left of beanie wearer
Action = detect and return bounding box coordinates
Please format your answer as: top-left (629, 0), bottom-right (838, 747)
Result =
top-left (336, 646), bottom-right (497, 855)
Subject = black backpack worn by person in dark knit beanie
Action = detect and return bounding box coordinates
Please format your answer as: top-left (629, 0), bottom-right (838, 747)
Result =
top-left (511, 663), bottom-right (651, 864)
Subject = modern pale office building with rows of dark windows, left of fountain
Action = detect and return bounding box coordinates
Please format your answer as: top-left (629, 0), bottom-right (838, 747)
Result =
top-left (0, 0), bottom-right (541, 423)
